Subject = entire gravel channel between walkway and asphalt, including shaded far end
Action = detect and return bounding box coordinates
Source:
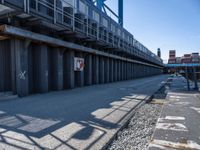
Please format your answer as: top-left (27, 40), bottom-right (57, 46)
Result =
top-left (106, 79), bottom-right (171, 150)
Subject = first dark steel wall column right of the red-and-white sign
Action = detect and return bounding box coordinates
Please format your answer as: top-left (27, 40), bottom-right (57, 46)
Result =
top-left (84, 54), bottom-right (93, 85)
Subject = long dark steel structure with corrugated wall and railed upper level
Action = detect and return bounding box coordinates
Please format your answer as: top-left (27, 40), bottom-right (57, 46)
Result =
top-left (0, 0), bottom-right (163, 97)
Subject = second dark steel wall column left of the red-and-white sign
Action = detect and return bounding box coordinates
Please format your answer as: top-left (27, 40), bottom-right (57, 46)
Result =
top-left (49, 48), bottom-right (64, 90)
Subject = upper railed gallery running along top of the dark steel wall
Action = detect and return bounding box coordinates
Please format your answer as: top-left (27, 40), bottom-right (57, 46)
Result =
top-left (1, 0), bottom-right (162, 64)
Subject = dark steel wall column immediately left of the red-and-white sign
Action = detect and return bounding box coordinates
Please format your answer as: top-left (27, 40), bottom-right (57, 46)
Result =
top-left (63, 50), bottom-right (75, 89)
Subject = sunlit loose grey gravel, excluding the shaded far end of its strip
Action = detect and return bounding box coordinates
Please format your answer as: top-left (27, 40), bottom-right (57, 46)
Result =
top-left (108, 104), bottom-right (162, 150)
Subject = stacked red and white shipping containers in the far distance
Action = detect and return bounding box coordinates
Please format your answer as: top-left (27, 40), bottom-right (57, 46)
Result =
top-left (168, 50), bottom-right (200, 64)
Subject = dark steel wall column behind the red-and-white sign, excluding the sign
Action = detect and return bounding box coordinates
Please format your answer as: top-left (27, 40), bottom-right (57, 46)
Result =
top-left (75, 52), bottom-right (84, 87)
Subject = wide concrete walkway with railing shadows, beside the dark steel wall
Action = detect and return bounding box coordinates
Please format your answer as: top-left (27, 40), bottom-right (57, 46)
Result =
top-left (0, 75), bottom-right (168, 150)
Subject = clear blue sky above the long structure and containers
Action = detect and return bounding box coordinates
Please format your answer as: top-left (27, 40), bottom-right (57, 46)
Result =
top-left (106, 0), bottom-right (200, 60)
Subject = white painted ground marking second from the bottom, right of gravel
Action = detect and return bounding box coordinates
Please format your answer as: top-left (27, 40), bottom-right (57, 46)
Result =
top-left (156, 123), bottom-right (188, 131)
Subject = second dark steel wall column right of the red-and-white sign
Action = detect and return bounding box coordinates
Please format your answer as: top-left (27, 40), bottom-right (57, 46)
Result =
top-left (92, 55), bottom-right (99, 84)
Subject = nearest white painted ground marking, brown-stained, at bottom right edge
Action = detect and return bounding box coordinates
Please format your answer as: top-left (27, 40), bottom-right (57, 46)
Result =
top-left (151, 140), bottom-right (200, 150)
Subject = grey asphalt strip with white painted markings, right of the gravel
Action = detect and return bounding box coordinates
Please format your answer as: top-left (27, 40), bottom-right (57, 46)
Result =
top-left (149, 77), bottom-right (200, 150)
